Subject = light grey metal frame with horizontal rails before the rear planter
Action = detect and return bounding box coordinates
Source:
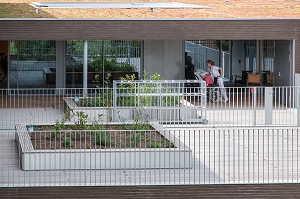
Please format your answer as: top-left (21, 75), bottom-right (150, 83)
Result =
top-left (113, 80), bottom-right (206, 124)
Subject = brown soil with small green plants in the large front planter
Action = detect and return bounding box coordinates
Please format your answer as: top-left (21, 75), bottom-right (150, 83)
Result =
top-left (29, 125), bottom-right (175, 150)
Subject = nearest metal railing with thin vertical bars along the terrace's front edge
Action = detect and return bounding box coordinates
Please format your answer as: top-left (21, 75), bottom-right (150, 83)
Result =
top-left (0, 125), bottom-right (300, 187)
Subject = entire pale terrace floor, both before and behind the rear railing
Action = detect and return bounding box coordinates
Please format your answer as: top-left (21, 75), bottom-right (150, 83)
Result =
top-left (0, 94), bottom-right (300, 186)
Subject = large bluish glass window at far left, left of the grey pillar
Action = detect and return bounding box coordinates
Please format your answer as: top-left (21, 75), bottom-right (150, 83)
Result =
top-left (8, 40), bottom-right (56, 88)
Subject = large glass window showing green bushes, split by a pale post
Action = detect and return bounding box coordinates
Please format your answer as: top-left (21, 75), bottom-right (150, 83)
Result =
top-left (66, 40), bottom-right (141, 88)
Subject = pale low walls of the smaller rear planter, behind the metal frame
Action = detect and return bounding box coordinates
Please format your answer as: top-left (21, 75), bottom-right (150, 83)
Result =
top-left (64, 97), bottom-right (201, 122)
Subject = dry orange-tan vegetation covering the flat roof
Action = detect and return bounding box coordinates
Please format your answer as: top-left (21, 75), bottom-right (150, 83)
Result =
top-left (0, 0), bottom-right (300, 18)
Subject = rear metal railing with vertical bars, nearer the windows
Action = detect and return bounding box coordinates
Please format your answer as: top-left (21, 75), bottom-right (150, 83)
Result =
top-left (0, 86), bottom-right (300, 129)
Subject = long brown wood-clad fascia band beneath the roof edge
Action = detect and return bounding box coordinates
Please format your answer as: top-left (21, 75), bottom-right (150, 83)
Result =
top-left (0, 19), bottom-right (300, 80)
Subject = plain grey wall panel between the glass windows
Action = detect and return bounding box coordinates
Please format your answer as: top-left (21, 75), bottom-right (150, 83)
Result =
top-left (143, 40), bottom-right (184, 79)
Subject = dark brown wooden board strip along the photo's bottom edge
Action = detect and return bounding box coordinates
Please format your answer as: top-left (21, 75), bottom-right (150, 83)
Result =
top-left (0, 183), bottom-right (300, 199)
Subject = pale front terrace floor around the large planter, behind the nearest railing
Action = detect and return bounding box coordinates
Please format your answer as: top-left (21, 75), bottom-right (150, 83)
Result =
top-left (0, 128), bottom-right (300, 186)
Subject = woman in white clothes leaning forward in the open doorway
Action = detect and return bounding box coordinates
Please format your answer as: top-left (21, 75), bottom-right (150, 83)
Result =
top-left (206, 60), bottom-right (228, 102)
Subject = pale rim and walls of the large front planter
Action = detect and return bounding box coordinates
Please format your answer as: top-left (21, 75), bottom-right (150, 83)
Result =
top-left (15, 123), bottom-right (192, 170)
